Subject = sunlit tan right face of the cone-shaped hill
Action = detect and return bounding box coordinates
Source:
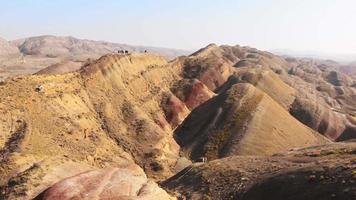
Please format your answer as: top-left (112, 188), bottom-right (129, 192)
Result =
top-left (230, 85), bottom-right (329, 155)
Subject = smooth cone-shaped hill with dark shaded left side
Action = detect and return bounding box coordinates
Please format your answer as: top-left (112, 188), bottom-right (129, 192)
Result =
top-left (174, 83), bottom-right (328, 160)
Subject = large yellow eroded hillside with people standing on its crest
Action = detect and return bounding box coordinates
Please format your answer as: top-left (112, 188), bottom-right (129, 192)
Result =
top-left (0, 54), bottom-right (189, 199)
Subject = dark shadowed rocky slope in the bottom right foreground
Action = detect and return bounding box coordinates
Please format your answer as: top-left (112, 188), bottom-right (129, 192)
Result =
top-left (162, 143), bottom-right (356, 200)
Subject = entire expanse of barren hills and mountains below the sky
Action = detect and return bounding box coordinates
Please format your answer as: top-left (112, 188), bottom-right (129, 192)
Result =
top-left (0, 37), bottom-right (356, 200)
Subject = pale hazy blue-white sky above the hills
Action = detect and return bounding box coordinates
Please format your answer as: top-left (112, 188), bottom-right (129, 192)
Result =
top-left (0, 0), bottom-right (356, 54)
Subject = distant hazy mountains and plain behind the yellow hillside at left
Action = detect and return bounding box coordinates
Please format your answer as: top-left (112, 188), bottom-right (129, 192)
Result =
top-left (0, 35), bottom-right (189, 80)
